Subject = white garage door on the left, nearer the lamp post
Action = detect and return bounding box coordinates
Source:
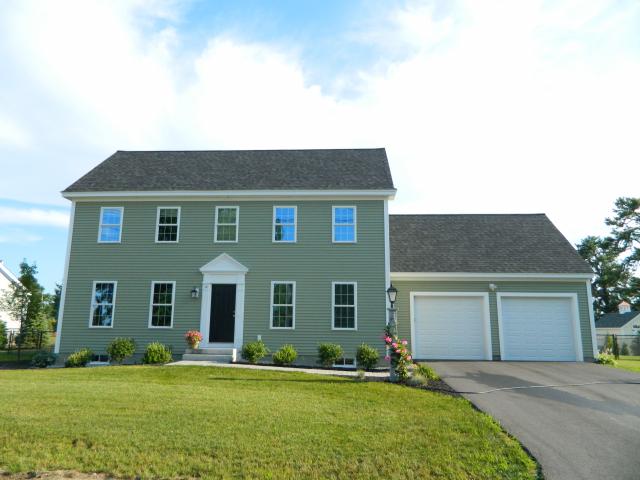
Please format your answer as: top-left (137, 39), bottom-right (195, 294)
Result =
top-left (412, 294), bottom-right (491, 360)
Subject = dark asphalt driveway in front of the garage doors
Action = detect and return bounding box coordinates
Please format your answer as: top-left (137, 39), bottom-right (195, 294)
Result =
top-left (430, 361), bottom-right (640, 480)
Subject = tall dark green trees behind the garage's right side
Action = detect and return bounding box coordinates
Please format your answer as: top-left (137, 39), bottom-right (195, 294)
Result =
top-left (577, 197), bottom-right (640, 317)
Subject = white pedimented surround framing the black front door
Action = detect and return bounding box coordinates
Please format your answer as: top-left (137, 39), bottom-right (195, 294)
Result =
top-left (200, 253), bottom-right (249, 349)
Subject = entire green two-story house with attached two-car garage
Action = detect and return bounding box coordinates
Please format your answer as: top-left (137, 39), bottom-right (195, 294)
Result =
top-left (56, 149), bottom-right (594, 365)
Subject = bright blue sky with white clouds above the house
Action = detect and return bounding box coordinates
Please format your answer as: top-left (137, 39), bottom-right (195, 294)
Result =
top-left (0, 0), bottom-right (640, 289)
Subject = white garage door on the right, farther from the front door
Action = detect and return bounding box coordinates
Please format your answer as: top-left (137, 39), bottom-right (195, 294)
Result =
top-left (499, 296), bottom-right (582, 361)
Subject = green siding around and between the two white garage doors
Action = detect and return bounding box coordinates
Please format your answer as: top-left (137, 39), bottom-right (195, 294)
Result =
top-left (391, 282), bottom-right (593, 360)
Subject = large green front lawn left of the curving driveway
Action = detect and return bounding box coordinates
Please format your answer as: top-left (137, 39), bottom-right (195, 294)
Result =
top-left (0, 367), bottom-right (536, 479)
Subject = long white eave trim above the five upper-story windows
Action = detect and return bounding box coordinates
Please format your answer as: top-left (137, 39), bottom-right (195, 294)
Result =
top-left (61, 188), bottom-right (397, 201)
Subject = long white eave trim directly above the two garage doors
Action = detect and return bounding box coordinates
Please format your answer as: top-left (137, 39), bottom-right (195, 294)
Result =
top-left (391, 272), bottom-right (593, 282)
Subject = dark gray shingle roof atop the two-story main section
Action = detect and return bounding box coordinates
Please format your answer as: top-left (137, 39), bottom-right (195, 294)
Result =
top-left (64, 148), bottom-right (394, 192)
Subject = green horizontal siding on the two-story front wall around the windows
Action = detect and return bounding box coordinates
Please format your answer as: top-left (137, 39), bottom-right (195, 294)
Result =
top-left (60, 200), bottom-right (386, 357)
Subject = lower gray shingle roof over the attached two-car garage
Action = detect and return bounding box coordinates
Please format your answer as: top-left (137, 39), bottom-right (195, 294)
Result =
top-left (389, 214), bottom-right (592, 273)
